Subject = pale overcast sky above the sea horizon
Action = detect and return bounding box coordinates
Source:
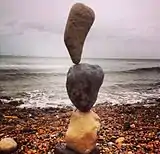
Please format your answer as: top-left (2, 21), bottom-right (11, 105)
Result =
top-left (0, 0), bottom-right (160, 58)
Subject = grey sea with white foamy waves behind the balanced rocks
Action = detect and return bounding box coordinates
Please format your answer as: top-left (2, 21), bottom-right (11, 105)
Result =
top-left (0, 56), bottom-right (160, 108)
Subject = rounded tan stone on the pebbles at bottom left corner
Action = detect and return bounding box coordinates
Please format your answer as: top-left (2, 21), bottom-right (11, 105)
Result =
top-left (0, 138), bottom-right (17, 153)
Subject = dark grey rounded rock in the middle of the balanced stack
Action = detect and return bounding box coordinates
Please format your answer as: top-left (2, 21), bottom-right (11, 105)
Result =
top-left (66, 64), bottom-right (104, 112)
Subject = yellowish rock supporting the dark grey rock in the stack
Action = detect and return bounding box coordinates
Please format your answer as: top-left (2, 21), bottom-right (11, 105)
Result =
top-left (66, 110), bottom-right (100, 154)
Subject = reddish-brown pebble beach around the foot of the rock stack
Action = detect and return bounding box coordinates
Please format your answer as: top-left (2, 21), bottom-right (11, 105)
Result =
top-left (0, 98), bottom-right (160, 154)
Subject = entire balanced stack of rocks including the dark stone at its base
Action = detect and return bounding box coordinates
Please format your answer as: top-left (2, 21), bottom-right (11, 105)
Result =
top-left (55, 3), bottom-right (104, 154)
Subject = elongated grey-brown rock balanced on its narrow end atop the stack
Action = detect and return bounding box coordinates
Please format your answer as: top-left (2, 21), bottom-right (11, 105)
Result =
top-left (64, 3), bottom-right (95, 64)
